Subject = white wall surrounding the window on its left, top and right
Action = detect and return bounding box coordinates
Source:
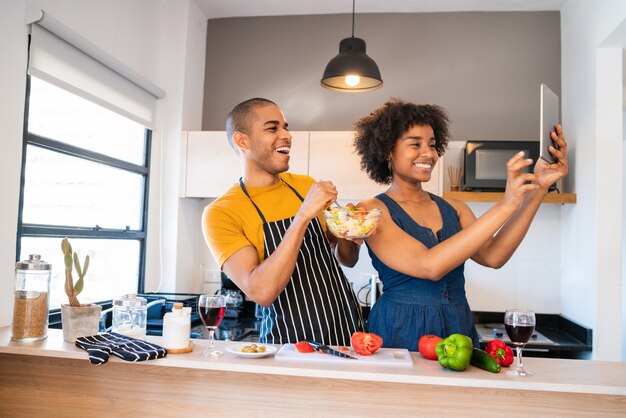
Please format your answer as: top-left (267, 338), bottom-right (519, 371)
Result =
top-left (0, 0), bottom-right (206, 326)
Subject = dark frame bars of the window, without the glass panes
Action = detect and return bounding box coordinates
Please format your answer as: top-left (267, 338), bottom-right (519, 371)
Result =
top-left (15, 74), bottom-right (152, 327)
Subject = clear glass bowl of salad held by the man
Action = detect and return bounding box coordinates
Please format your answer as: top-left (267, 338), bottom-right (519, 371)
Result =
top-left (324, 206), bottom-right (382, 238)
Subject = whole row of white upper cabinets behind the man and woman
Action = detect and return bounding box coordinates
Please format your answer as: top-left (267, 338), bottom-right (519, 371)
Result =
top-left (180, 131), bottom-right (443, 198)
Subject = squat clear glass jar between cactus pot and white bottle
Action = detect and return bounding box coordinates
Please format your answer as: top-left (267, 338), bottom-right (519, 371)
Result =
top-left (111, 293), bottom-right (148, 340)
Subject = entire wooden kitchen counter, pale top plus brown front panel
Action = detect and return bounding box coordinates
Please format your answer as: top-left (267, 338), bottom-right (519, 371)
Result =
top-left (0, 327), bottom-right (626, 418)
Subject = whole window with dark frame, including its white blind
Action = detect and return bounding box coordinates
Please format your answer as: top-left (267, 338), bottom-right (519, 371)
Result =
top-left (16, 11), bottom-right (165, 316)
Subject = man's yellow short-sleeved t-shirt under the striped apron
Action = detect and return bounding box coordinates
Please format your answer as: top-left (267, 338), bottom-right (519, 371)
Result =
top-left (202, 173), bottom-right (326, 268)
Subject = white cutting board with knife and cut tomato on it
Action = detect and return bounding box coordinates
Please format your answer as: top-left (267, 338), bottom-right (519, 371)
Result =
top-left (274, 344), bottom-right (413, 367)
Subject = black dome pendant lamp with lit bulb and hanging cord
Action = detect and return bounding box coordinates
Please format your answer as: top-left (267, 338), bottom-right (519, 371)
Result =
top-left (321, 0), bottom-right (383, 93)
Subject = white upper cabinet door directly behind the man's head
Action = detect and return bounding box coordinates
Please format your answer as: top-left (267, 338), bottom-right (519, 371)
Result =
top-left (180, 131), bottom-right (309, 198)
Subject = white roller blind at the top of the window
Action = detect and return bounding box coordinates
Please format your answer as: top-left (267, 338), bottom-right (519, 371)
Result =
top-left (26, 8), bottom-right (165, 128)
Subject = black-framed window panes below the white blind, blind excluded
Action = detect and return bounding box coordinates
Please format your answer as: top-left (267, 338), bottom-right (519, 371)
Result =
top-left (17, 76), bottom-right (151, 309)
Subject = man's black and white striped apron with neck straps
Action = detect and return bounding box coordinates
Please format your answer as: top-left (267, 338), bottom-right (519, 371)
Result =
top-left (239, 179), bottom-right (363, 345)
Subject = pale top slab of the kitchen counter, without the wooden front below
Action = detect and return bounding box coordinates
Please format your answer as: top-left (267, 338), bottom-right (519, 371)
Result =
top-left (0, 327), bottom-right (626, 396)
